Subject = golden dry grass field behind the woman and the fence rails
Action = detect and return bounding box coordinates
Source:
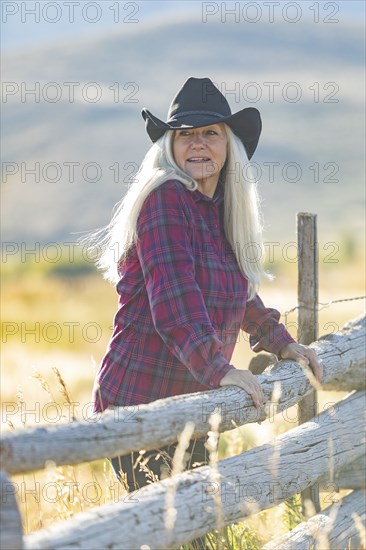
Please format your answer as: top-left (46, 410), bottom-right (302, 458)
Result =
top-left (1, 242), bottom-right (364, 548)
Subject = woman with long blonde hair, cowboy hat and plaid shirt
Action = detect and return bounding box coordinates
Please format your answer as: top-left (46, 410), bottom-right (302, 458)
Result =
top-left (90, 78), bottom-right (320, 496)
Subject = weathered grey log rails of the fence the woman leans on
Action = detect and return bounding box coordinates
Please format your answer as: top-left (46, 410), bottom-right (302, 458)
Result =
top-left (1, 317), bottom-right (366, 550)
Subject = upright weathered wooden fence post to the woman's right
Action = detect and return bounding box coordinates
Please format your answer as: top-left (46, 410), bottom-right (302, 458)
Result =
top-left (297, 212), bottom-right (320, 517)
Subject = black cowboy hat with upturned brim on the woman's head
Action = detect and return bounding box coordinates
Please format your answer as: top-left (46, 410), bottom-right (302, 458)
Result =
top-left (141, 77), bottom-right (262, 159)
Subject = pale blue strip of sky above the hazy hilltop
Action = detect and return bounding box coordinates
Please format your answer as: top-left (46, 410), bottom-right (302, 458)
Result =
top-left (1, 0), bottom-right (365, 53)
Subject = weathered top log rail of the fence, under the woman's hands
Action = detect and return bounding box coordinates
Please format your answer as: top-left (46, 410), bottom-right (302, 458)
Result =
top-left (0, 317), bottom-right (366, 474)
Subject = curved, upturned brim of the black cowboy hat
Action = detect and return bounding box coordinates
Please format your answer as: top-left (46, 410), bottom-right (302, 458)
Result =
top-left (141, 107), bottom-right (262, 160)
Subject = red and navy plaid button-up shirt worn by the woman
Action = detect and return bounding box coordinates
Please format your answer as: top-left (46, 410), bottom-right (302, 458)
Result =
top-left (93, 180), bottom-right (294, 411)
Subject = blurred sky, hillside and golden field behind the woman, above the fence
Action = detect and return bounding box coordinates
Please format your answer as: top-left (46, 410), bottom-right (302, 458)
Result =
top-left (1, 0), bottom-right (365, 416)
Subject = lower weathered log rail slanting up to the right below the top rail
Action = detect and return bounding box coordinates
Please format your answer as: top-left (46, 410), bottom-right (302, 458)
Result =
top-left (24, 392), bottom-right (365, 550)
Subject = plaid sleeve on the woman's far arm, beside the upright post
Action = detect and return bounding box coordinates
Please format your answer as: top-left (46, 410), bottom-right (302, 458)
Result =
top-left (241, 294), bottom-right (295, 355)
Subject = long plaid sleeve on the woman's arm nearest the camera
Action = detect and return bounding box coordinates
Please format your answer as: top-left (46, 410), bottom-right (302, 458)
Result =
top-left (136, 182), bottom-right (235, 388)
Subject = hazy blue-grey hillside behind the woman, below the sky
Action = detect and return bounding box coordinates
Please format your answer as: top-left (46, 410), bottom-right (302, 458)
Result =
top-left (2, 16), bottom-right (365, 250)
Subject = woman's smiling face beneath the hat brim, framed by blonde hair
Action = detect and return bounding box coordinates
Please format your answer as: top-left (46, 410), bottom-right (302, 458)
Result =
top-left (173, 123), bottom-right (227, 196)
